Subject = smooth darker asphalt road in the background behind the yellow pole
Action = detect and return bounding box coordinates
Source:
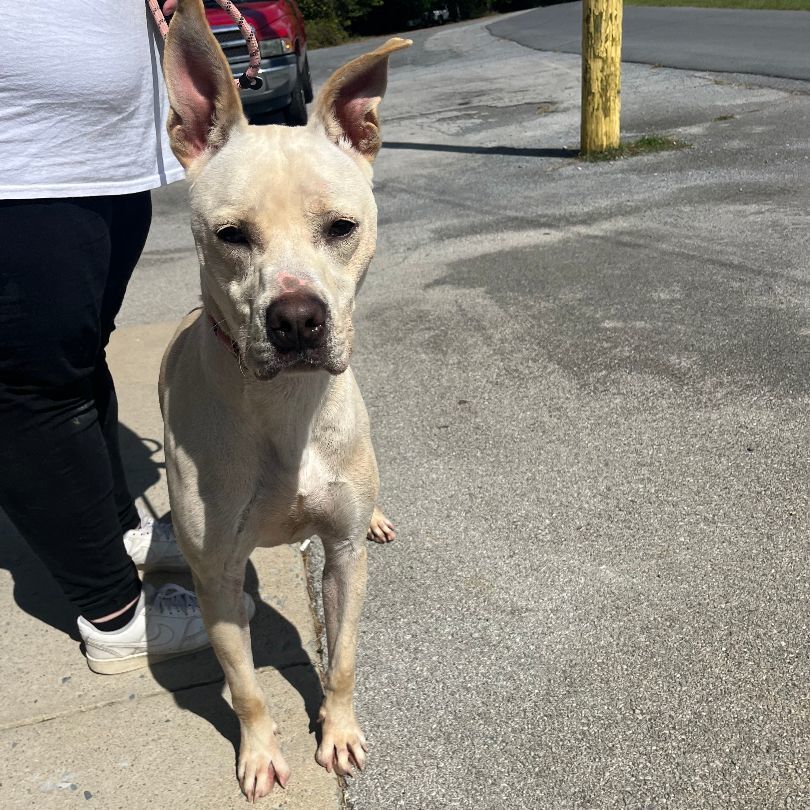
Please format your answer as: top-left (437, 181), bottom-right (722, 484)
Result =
top-left (490, 3), bottom-right (810, 80)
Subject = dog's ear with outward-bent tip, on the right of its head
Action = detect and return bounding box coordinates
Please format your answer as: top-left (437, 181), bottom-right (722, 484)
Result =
top-left (312, 37), bottom-right (413, 163)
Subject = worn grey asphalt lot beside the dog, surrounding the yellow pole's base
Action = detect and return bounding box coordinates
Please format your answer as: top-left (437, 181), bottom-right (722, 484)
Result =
top-left (124, 12), bottom-right (810, 810)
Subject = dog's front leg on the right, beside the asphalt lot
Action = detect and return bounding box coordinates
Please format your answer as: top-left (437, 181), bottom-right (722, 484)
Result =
top-left (315, 537), bottom-right (368, 774)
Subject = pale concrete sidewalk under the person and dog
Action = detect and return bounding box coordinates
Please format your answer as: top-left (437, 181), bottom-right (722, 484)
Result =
top-left (0, 324), bottom-right (341, 810)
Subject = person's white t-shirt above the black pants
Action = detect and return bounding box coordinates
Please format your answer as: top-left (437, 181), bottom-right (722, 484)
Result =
top-left (0, 0), bottom-right (183, 199)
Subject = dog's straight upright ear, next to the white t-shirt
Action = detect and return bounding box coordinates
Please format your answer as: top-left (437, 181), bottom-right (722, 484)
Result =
top-left (163, 0), bottom-right (247, 169)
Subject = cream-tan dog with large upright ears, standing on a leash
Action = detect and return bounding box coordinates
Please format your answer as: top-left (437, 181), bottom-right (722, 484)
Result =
top-left (160, 0), bottom-right (411, 800)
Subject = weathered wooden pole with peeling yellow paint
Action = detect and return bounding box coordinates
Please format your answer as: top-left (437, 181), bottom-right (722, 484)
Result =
top-left (580, 0), bottom-right (622, 155)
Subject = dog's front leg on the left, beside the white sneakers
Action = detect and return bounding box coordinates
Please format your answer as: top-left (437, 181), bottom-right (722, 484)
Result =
top-left (194, 564), bottom-right (290, 802)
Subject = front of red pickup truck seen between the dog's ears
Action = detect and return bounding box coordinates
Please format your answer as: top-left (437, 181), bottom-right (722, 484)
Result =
top-left (205, 0), bottom-right (312, 126)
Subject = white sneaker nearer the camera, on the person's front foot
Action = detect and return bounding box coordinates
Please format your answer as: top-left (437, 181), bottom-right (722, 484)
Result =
top-left (77, 583), bottom-right (256, 675)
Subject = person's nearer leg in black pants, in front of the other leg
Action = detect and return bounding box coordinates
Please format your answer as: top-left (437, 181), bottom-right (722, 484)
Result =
top-left (0, 200), bottom-right (140, 619)
